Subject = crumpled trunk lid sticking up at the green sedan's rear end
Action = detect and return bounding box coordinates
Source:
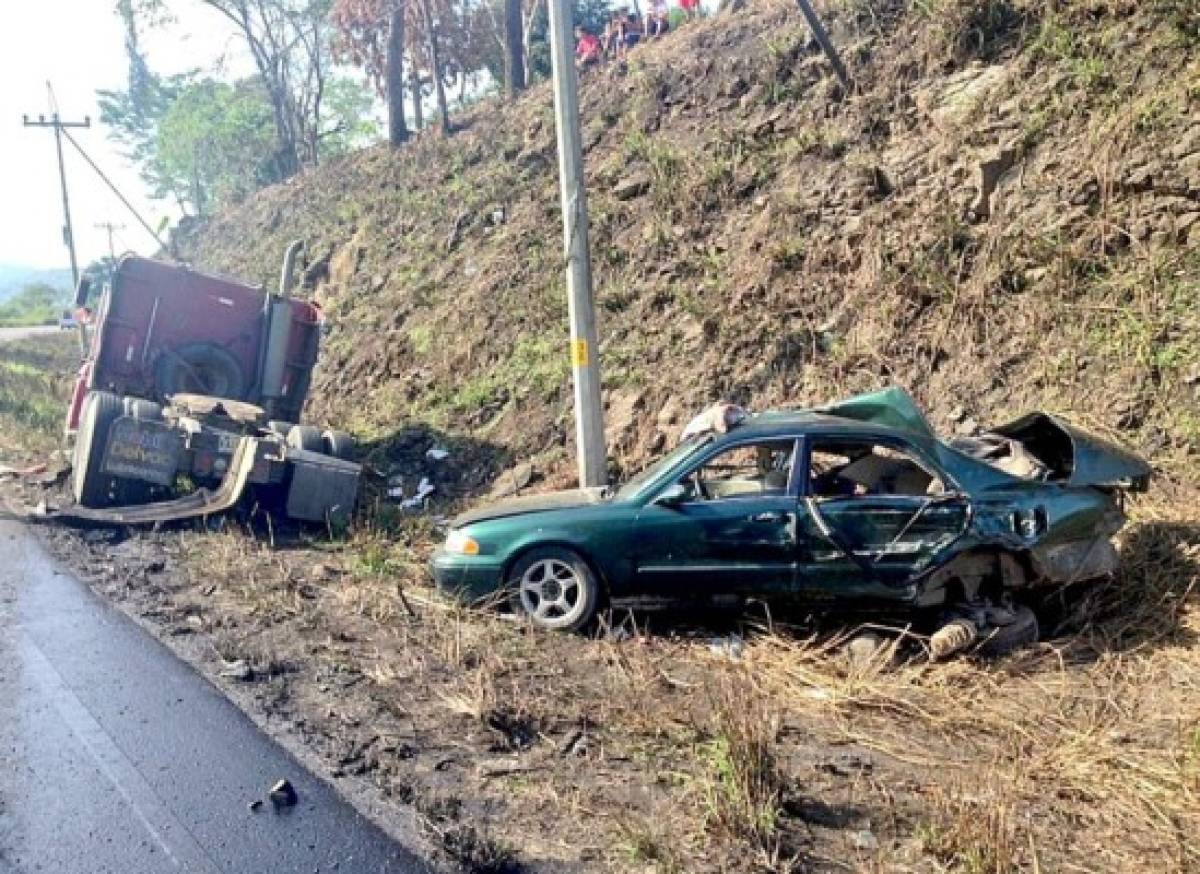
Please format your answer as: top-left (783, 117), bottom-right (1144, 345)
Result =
top-left (992, 413), bottom-right (1152, 491)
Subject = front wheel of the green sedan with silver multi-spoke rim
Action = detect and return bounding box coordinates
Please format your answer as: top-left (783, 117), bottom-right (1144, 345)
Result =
top-left (508, 546), bottom-right (600, 631)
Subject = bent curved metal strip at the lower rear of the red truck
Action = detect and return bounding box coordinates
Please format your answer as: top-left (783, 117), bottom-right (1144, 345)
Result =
top-left (32, 436), bottom-right (258, 527)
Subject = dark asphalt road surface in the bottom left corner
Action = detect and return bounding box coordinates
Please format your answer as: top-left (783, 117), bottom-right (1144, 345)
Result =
top-left (0, 521), bottom-right (428, 874)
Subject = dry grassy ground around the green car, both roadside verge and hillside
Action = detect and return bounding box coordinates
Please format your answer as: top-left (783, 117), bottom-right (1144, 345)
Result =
top-left (9, 0), bottom-right (1200, 872)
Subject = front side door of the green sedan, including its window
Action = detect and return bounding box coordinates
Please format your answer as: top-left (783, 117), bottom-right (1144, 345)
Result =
top-left (634, 438), bottom-right (800, 599)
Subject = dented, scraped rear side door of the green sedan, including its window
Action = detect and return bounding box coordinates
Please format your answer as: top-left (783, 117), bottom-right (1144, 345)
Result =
top-left (797, 435), bottom-right (970, 609)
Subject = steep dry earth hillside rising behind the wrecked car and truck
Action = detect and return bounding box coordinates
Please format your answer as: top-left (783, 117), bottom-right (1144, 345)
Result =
top-left (180, 0), bottom-right (1200, 489)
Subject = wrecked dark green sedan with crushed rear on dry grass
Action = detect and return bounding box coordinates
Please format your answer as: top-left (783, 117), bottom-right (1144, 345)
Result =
top-left (433, 388), bottom-right (1151, 648)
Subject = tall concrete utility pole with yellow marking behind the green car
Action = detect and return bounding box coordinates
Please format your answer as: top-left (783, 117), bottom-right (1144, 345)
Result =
top-left (548, 0), bottom-right (608, 486)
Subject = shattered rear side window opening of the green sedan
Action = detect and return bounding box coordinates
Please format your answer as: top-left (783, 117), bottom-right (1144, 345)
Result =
top-left (809, 438), bottom-right (946, 498)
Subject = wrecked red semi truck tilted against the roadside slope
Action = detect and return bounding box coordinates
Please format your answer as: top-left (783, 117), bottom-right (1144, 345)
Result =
top-left (53, 243), bottom-right (361, 525)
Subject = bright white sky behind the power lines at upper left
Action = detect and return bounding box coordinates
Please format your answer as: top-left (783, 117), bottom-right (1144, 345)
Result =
top-left (0, 0), bottom-right (248, 269)
